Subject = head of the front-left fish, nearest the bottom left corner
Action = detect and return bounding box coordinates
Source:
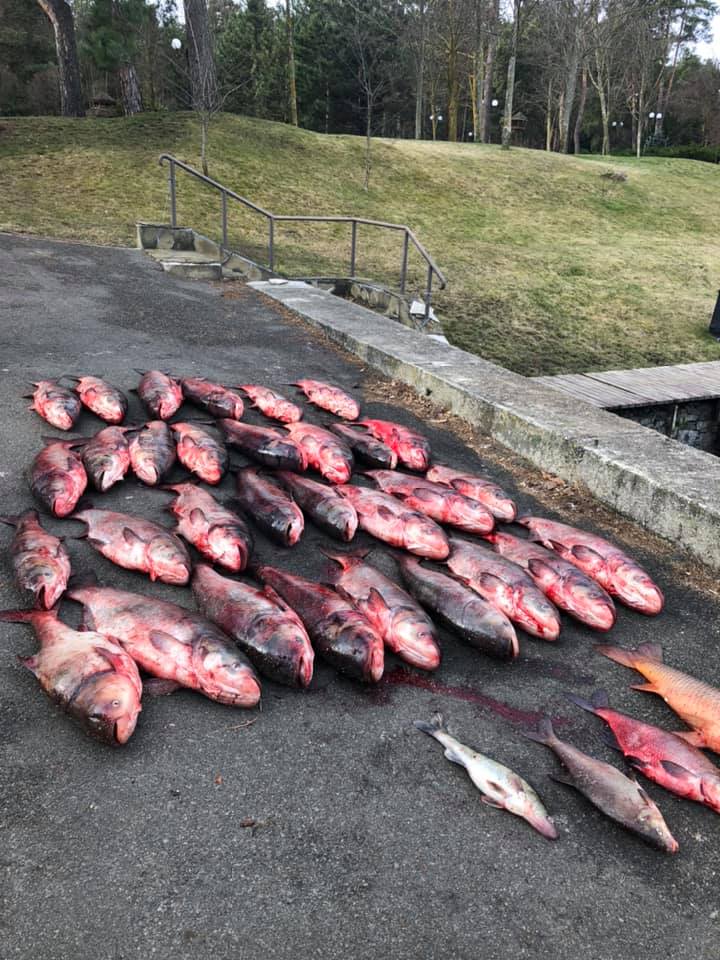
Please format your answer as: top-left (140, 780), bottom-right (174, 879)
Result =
top-left (72, 671), bottom-right (142, 743)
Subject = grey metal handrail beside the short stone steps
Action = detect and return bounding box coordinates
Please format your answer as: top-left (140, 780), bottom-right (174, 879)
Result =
top-left (159, 153), bottom-right (447, 320)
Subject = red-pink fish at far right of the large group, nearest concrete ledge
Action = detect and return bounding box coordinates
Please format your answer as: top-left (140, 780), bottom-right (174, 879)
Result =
top-left (518, 517), bottom-right (665, 616)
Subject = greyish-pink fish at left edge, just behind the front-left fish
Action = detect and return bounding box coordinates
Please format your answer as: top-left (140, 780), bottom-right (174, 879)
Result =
top-left (0, 510), bottom-right (70, 610)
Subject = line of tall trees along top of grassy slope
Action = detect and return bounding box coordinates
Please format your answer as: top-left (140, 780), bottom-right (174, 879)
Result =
top-left (5, 0), bottom-right (720, 159)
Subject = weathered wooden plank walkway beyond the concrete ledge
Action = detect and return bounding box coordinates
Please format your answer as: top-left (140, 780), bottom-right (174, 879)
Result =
top-left (534, 360), bottom-right (720, 410)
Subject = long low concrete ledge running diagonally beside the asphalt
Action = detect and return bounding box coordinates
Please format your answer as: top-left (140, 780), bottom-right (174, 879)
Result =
top-left (250, 281), bottom-right (720, 569)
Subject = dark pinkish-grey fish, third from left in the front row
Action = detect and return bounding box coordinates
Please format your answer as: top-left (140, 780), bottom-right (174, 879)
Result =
top-left (192, 563), bottom-right (315, 687)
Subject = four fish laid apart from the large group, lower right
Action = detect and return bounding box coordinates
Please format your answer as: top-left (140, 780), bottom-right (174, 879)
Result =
top-left (415, 643), bottom-right (720, 853)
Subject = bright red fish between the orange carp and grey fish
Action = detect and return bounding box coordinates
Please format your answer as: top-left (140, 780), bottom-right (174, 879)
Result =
top-left (568, 690), bottom-right (720, 813)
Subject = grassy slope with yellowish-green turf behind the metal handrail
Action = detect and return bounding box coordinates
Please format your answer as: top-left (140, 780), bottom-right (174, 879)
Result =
top-left (0, 114), bottom-right (720, 374)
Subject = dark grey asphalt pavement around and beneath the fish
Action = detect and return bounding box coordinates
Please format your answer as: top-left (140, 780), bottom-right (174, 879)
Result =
top-left (0, 236), bottom-right (720, 960)
